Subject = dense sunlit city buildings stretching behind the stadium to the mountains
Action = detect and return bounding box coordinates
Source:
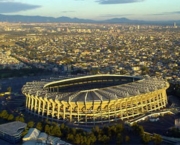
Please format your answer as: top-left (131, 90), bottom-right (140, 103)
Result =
top-left (0, 23), bottom-right (180, 84)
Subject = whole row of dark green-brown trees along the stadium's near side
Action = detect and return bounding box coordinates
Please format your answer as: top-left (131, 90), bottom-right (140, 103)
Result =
top-left (0, 110), bottom-right (162, 145)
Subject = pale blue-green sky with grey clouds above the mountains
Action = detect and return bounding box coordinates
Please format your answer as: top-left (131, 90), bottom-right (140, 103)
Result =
top-left (0, 0), bottom-right (180, 20)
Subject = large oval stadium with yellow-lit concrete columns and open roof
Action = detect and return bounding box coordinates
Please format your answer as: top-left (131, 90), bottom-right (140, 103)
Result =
top-left (22, 74), bottom-right (169, 124)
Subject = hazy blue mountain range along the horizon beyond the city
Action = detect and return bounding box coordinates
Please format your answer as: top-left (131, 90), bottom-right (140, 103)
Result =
top-left (0, 14), bottom-right (180, 25)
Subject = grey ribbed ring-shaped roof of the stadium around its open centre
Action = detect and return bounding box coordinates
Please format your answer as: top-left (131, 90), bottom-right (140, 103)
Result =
top-left (22, 75), bottom-right (168, 102)
